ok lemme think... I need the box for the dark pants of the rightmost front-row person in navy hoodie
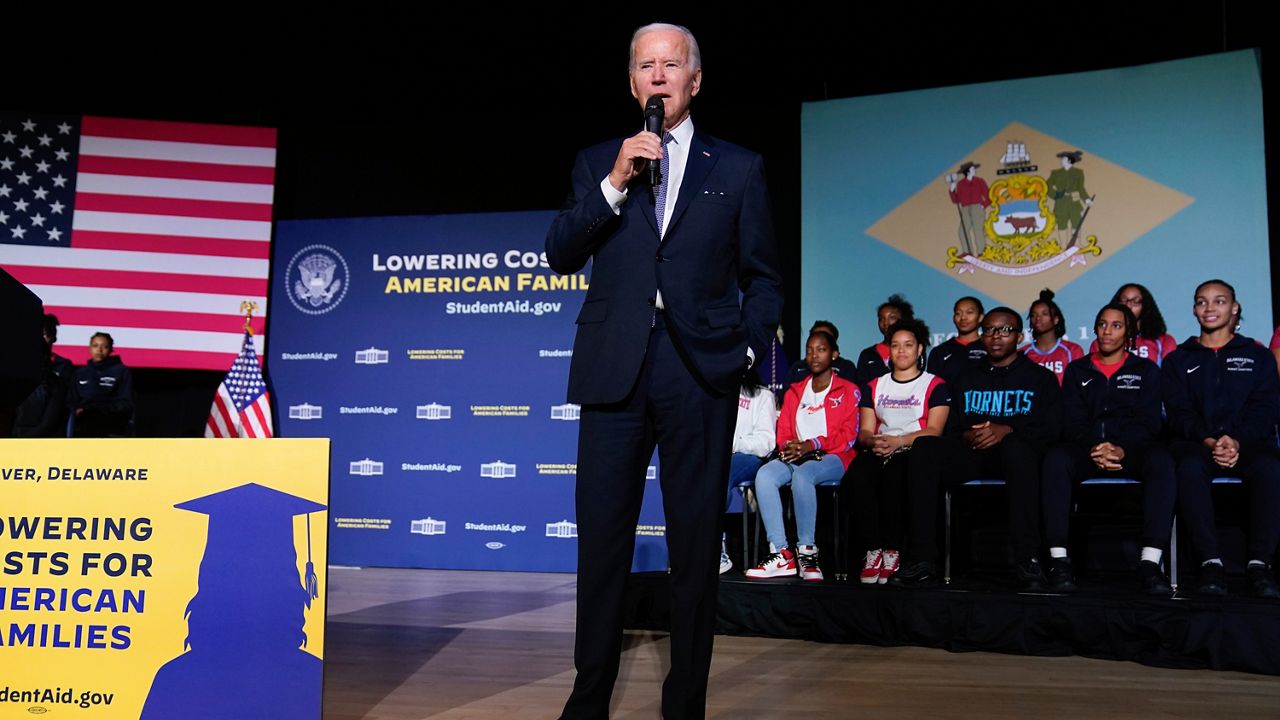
[1172,442,1280,562]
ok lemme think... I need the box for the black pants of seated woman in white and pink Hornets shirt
[841,450,914,551]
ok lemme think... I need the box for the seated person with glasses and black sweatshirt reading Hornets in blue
[890,307,1062,591]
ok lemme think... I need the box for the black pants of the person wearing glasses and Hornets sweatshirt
[906,433,1041,562]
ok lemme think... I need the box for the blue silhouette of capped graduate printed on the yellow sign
[141,483,325,720]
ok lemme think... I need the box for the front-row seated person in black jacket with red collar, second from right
[1041,302,1175,596]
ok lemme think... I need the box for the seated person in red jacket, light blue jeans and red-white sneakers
[746,331,859,580]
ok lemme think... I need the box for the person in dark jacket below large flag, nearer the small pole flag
[72,333,133,437]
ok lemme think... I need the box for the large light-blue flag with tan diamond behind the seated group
[801,49,1274,355]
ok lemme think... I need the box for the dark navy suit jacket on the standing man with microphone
[547,132,782,404]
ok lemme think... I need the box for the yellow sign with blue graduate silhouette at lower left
[0,439,329,720]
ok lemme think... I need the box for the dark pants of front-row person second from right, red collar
[1041,442,1176,547]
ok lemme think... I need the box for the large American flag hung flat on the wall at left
[0,114,275,370]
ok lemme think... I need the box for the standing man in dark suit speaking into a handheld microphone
[547,24,782,720]
